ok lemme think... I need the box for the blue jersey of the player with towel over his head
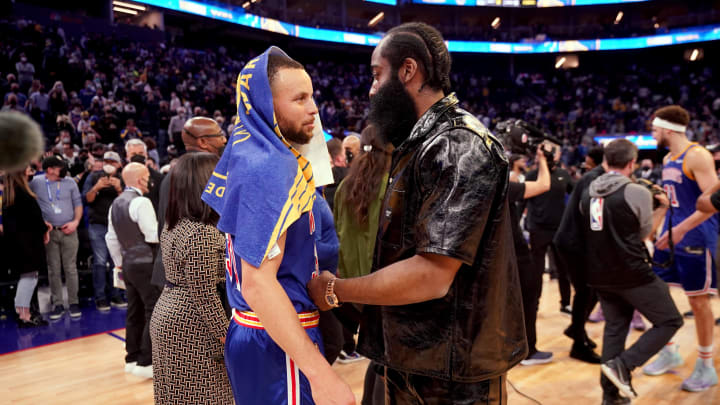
[225,211,318,313]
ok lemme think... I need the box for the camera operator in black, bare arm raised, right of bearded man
[508,146,553,365]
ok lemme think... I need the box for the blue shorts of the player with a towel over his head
[225,310,322,405]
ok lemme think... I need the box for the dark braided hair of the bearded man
[381,22,452,93]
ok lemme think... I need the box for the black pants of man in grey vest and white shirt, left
[123,263,162,366]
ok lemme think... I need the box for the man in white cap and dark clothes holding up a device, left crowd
[83,152,127,311]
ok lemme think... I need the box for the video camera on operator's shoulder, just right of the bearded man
[495,118,562,168]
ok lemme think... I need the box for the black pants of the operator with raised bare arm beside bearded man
[517,249,542,356]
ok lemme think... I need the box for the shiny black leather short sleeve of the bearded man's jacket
[415,128,507,265]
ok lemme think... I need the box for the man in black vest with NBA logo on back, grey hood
[580,139,683,404]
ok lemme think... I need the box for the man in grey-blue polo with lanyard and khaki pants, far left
[30,156,83,320]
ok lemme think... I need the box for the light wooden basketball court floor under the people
[0,281,720,405]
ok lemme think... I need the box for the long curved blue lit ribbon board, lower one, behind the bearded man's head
[135,0,720,54]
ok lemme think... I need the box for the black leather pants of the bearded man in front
[385,367,507,405]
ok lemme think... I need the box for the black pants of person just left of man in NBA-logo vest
[555,248,597,344]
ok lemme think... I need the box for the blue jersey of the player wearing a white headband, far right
[662,143,718,255]
